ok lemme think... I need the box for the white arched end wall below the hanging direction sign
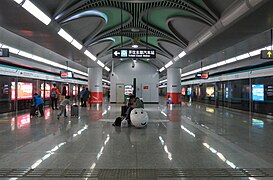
[110,60,159,102]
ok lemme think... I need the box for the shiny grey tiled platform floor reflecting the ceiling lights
[0,102,273,180]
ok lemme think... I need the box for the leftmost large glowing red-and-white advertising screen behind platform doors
[11,82,33,100]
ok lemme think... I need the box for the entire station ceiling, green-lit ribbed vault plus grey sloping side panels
[0,0,273,75]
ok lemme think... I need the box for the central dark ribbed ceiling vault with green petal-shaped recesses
[55,0,219,61]
